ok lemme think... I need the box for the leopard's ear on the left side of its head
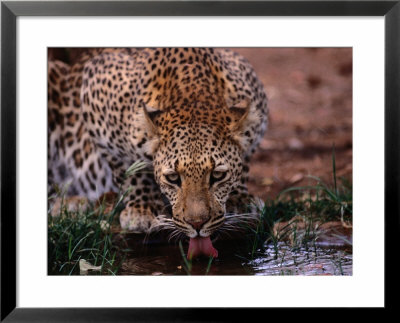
[142,103,163,156]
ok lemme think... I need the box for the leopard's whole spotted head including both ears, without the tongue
[144,100,249,238]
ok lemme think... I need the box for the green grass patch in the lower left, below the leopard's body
[48,197,121,275]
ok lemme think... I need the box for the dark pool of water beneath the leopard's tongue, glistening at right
[119,234,353,276]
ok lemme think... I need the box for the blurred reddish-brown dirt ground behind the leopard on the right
[235,48,353,199]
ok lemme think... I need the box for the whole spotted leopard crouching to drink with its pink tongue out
[48,48,268,257]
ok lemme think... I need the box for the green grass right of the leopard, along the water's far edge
[247,147,353,259]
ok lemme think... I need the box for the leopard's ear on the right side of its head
[229,98,251,149]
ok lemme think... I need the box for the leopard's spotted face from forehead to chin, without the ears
[149,106,243,238]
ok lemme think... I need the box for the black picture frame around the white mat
[1,0,400,322]
